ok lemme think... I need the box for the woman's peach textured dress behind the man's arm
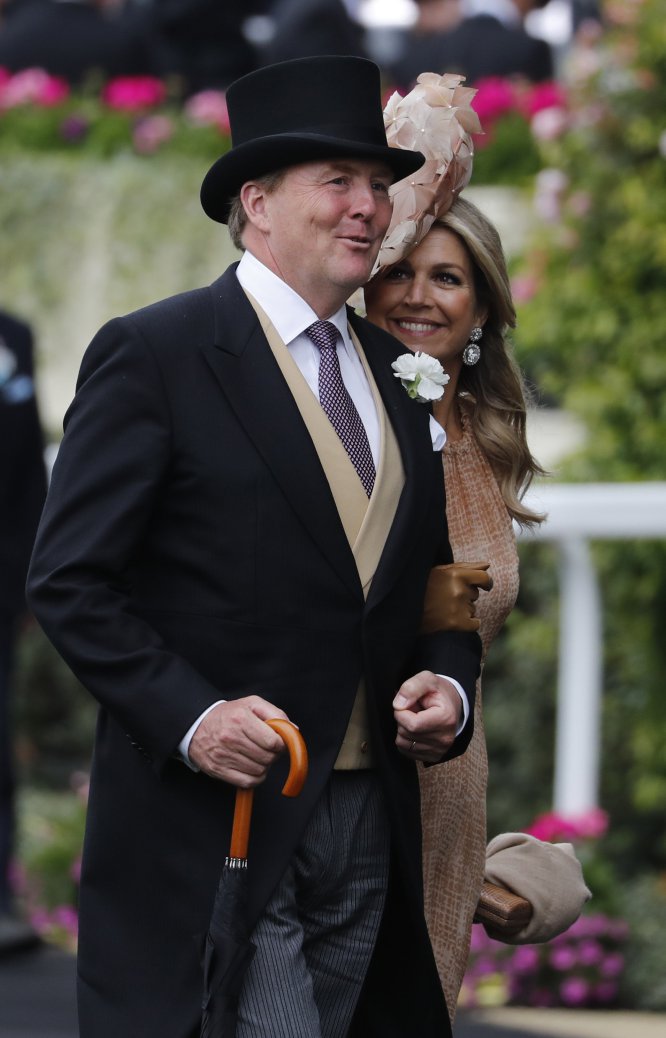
[419,422,518,1019]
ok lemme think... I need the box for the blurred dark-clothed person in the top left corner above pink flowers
[0,0,151,86]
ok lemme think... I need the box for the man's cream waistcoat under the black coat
[240,293,405,769]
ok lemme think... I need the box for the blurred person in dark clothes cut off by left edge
[0,310,47,952]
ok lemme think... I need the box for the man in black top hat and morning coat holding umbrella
[29,57,479,1038]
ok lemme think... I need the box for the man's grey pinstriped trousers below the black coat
[237,771,389,1038]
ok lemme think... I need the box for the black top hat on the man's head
[201,55,424,223]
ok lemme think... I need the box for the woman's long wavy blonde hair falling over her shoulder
[435,197,546,526]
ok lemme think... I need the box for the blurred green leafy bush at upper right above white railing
[518,0,666,481]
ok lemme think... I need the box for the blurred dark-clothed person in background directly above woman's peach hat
[390,0,554,87]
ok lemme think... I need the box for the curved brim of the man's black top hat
[201,133,425,223]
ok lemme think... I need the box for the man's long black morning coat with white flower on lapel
[28,267,480,1038]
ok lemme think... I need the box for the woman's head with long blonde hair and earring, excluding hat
[365,197,540,512]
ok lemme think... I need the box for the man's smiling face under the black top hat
[255,159,393,317]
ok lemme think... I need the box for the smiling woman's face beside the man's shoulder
[365,224,485,375]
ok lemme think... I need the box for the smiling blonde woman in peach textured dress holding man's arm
[365,133,542,1016]
